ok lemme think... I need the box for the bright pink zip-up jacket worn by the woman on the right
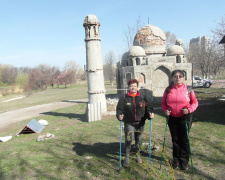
[161,84,198,117]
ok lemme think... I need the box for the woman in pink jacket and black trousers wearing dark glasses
[161,70,198,170]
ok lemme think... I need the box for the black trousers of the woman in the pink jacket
[168,114,192,164]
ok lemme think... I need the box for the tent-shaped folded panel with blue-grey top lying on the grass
[16,119,45,136]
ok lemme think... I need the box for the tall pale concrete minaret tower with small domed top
[83,14,107,114]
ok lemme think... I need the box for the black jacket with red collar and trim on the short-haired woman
[116,91,153,122]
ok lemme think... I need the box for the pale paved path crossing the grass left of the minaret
[0,99,88,133]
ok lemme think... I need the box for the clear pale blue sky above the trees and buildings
[0,0,225,68]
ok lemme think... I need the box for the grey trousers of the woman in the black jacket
[124,122,144,157]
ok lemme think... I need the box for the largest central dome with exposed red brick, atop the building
[133,24,166,54]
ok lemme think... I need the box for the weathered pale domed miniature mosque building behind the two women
[117,25,192,100]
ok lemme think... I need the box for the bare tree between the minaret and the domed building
[103,51,116,85]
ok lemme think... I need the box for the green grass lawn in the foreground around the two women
[0,87,225,180]
